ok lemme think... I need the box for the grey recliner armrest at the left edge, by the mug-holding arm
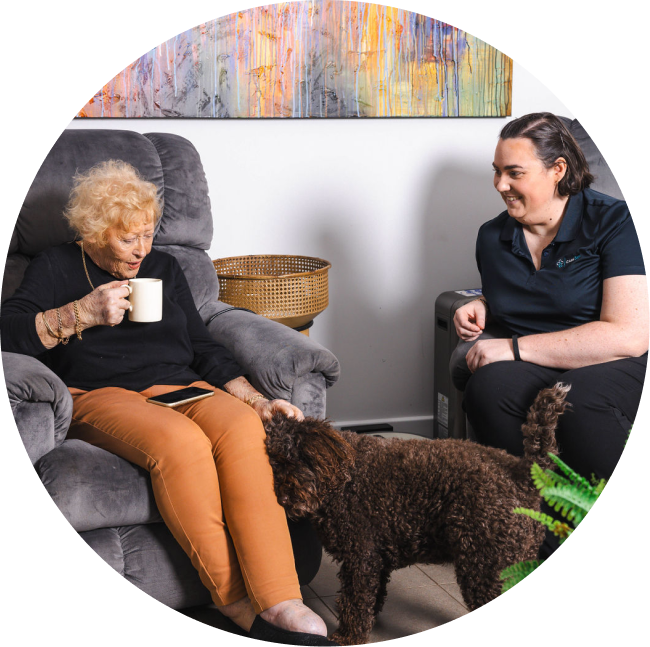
[2,351,72,464]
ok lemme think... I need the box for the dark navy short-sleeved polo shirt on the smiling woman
[476,189,646,335]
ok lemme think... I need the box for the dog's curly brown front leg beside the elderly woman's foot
[331,551,382,645]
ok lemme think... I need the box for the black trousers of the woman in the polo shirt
[464,355,648,557]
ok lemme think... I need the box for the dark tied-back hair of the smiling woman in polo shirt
[499,112,594,195]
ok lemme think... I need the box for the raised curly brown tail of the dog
[521,382,571,474]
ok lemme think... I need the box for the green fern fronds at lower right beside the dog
[500,425,634,594]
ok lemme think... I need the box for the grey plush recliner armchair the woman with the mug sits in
[2,129,339,609]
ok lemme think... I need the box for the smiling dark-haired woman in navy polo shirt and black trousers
[454,113,650,555]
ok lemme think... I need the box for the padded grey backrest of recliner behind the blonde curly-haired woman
[1,129,218,306]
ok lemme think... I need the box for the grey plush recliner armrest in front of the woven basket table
[208,303,340,408]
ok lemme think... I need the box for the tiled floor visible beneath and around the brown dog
[182,554,468,643]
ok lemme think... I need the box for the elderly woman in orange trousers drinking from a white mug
[0,161,334,645]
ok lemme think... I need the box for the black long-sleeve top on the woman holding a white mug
[0,243,244,391]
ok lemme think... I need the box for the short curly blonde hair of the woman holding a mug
[63,160,162,247]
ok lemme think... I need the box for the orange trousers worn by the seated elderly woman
[68,382,301,613]
